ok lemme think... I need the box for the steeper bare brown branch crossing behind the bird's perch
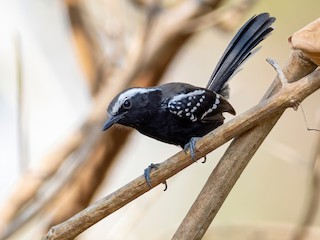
[173,51,317,239]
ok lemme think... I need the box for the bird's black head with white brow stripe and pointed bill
[103,87,161,131]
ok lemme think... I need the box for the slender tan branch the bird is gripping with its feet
[43,58,320,240]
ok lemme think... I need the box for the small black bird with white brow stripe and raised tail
[103,13,276,187]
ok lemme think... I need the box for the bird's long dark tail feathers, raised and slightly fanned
[207,13,276,97]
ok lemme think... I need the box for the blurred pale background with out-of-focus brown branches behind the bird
[0,0,320,239]
